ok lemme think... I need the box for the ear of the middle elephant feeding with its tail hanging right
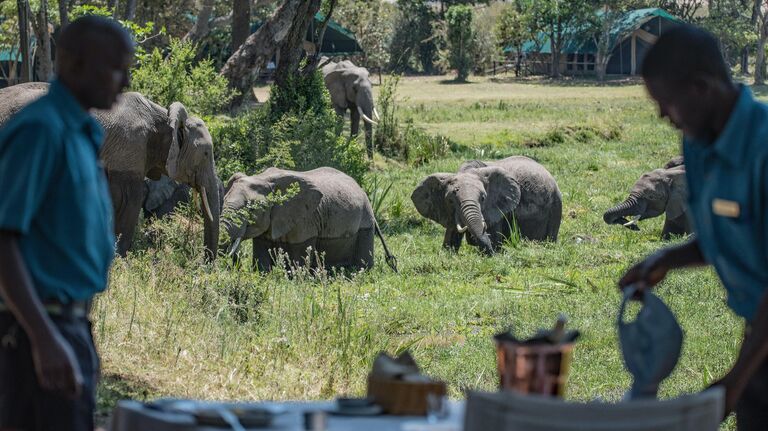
[271,178,323,240]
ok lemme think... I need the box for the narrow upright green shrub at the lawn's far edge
[445,5,474,82]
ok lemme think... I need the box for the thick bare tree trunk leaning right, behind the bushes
[220,0,320,107]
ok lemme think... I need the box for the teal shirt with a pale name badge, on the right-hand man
[683,86,768,321]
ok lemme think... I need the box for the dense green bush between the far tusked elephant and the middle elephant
[208,72,368,182]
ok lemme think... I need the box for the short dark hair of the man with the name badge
[640,24,731,83]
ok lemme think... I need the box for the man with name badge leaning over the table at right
[619,26,768,430]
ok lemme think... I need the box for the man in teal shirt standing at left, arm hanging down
[0,17,133,431]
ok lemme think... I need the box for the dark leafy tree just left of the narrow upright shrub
[389,0,439,74]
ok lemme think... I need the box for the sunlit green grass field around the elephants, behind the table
[94,78,741,429]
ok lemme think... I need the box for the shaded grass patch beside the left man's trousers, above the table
[96,373,157,427]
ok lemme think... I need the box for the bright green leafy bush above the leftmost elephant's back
[131,39,235,115]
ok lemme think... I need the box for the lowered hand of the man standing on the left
[31,331,83,398]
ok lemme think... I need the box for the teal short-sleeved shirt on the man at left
[0,81,115,303]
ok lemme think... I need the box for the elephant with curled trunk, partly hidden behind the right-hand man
[603,165,691,239]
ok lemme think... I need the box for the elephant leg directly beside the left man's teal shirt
[107,172,144,257]
